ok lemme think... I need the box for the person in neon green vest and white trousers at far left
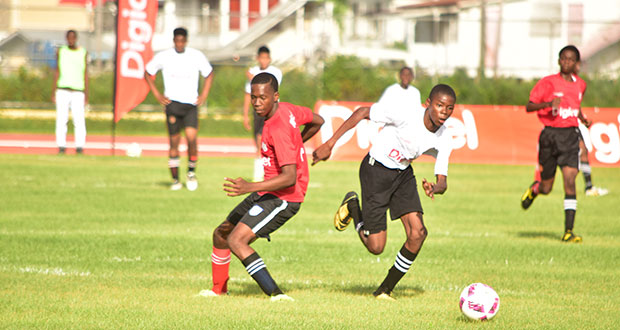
[52,30,88,154]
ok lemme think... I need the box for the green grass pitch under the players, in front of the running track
[0,155,620,329]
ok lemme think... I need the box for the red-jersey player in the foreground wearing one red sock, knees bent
[199,72,323,301]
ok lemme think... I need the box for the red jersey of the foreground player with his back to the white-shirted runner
[259,102,313,203]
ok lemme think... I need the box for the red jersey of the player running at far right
[530,73,586,127]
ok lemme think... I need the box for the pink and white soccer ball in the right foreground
[459,283,499,321]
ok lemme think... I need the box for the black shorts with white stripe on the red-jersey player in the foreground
[226,193,301,238]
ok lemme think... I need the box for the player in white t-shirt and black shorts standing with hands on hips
[144,28,213,191]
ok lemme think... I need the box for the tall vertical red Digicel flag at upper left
[114,0,157,122]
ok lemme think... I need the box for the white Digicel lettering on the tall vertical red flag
[120,0,153,79]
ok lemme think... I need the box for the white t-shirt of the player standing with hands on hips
[146,47,213,104]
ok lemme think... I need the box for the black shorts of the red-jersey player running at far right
[538,127,581,180]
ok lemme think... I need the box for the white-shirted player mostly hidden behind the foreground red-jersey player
[243,46,282,182]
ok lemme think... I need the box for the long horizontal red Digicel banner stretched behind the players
[313,101,620,167]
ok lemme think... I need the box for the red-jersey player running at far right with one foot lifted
[521,45,590,243]
